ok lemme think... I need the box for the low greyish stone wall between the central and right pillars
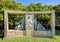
[34,31,52,37]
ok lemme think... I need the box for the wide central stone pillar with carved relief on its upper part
[25,14,34,37]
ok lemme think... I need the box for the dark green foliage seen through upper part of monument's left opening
[8,15,24,25]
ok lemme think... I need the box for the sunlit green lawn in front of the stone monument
[0,31,60,42]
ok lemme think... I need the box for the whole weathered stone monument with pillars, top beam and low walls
[4,10,55,38]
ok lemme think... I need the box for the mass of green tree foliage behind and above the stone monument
[0,0,60,27]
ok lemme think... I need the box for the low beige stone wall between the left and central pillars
[7,30,25,38]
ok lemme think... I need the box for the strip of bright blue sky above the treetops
[15,0,60,5]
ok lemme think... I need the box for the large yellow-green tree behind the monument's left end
[0,0,26,28]
